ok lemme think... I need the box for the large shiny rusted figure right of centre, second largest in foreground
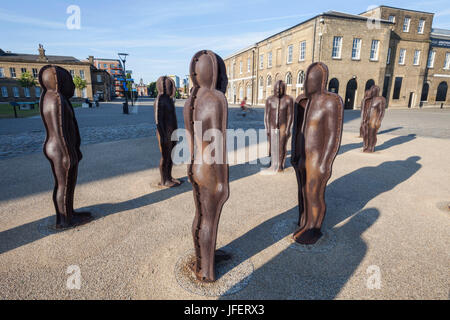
[291,62,344,244]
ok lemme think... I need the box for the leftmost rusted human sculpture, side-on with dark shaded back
[39,65,92,228]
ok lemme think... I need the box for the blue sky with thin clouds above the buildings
[0,0,450,83]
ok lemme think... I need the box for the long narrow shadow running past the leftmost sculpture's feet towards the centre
[0,163,261,254]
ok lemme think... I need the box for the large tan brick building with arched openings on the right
[225,6,450,109]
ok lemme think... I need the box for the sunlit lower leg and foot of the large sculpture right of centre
[293,165,327,244]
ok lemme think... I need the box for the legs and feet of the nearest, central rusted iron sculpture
[192,185,228,282]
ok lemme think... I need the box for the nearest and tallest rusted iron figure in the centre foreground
[183,50,229,282]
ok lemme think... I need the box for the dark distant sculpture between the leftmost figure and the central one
[154,77,181,188]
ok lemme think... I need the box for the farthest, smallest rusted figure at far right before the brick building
[363,86,386,153]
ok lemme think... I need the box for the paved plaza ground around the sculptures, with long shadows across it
[0,99,450,299]
